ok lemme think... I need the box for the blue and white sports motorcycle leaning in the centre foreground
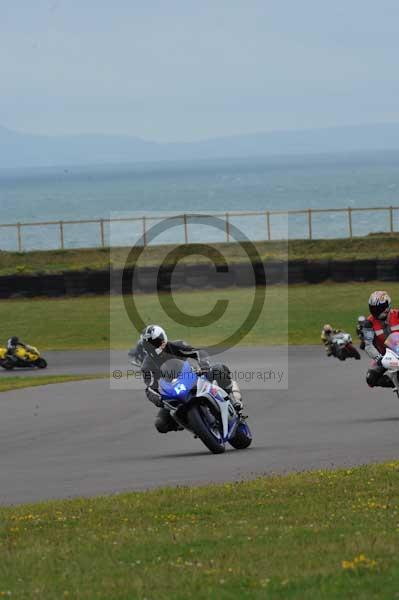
[159,360,252,454]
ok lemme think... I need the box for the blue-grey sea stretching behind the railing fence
[0,151,399,250]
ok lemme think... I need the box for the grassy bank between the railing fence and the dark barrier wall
[0,233,399,275]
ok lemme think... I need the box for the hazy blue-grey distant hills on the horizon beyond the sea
[0,123,399,168]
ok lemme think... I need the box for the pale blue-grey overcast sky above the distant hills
[0,0,399,141]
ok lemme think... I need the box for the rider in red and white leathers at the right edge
[363,291,399,387]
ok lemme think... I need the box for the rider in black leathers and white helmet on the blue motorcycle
[141,325,242,433]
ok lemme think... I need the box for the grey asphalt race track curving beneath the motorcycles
[0,347,399,504]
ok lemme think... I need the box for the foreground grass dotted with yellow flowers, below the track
[0,462,399,600]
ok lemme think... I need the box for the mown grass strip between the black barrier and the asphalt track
[0,282,399,350]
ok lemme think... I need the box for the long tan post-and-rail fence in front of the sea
[0,206,399,252]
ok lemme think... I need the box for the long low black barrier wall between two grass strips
[0,258,399,298]
